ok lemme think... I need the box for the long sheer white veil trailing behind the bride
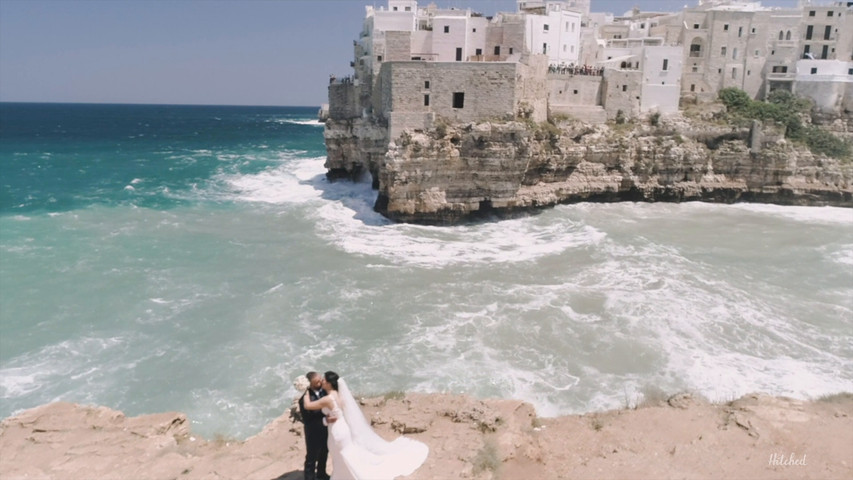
[338,378,429,476]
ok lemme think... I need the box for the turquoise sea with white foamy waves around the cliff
[0,103,853,438]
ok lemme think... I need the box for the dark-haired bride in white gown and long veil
[304,372,429,480]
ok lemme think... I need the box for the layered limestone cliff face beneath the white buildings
[326,119,853,224]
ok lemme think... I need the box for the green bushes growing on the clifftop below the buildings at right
[720,88,853,161]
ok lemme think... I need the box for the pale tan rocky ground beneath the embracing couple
[0,394,853,480]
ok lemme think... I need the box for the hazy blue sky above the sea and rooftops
[0,0,796,106]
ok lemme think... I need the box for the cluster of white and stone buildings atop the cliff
[329,0,853,138]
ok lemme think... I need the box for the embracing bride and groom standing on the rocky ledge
[299,372,429,480]
